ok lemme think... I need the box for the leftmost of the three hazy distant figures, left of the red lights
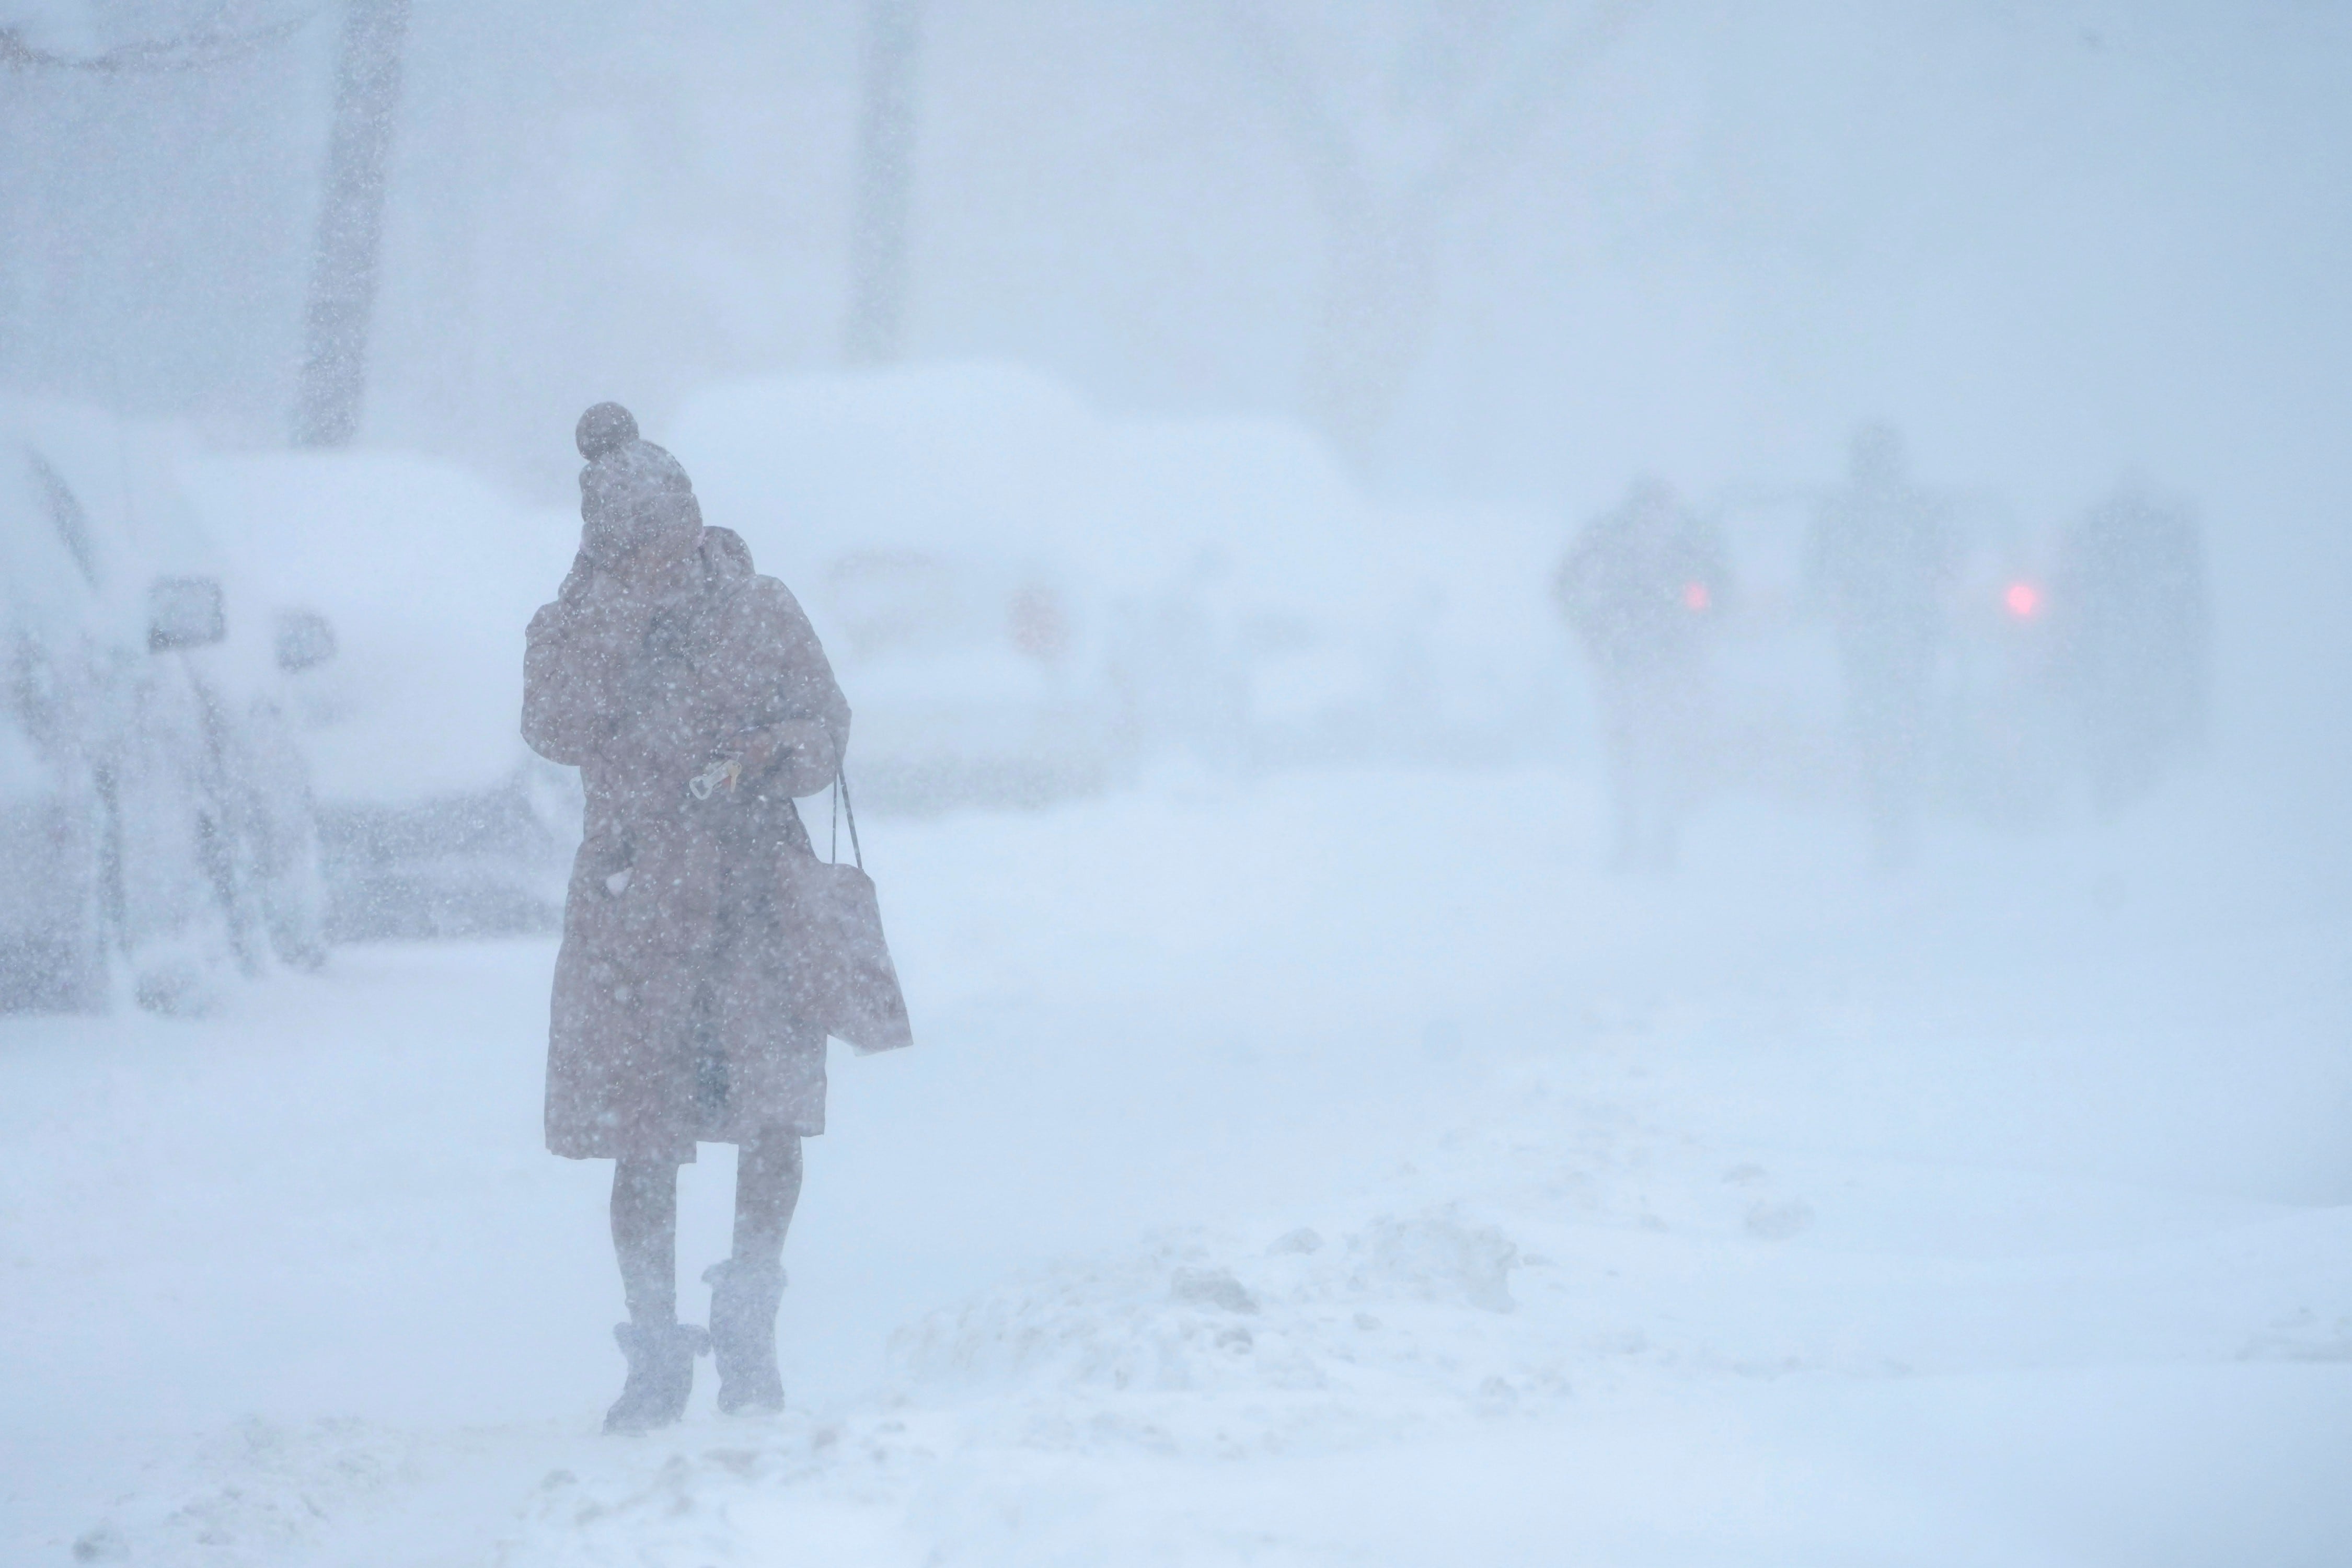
[1552,480,1726,870]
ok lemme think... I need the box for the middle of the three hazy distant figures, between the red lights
[1811,425,1959,870]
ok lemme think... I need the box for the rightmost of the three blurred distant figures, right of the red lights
[2051,482,2206,818]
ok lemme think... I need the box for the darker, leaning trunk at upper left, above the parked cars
[294,0,409,447]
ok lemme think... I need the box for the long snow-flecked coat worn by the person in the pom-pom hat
[522,529,849,1161]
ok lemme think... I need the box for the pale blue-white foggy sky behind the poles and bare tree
[0,0,2352,841]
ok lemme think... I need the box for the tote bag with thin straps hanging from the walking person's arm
[783,774,915,1055]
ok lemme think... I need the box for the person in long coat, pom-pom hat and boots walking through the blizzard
[522,405,849,1432]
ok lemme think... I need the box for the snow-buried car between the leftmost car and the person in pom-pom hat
[183,452,581,940]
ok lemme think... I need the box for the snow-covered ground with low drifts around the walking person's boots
[0,771,2352,1568]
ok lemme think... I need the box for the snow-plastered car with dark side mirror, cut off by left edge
[0,400,322,1011]
